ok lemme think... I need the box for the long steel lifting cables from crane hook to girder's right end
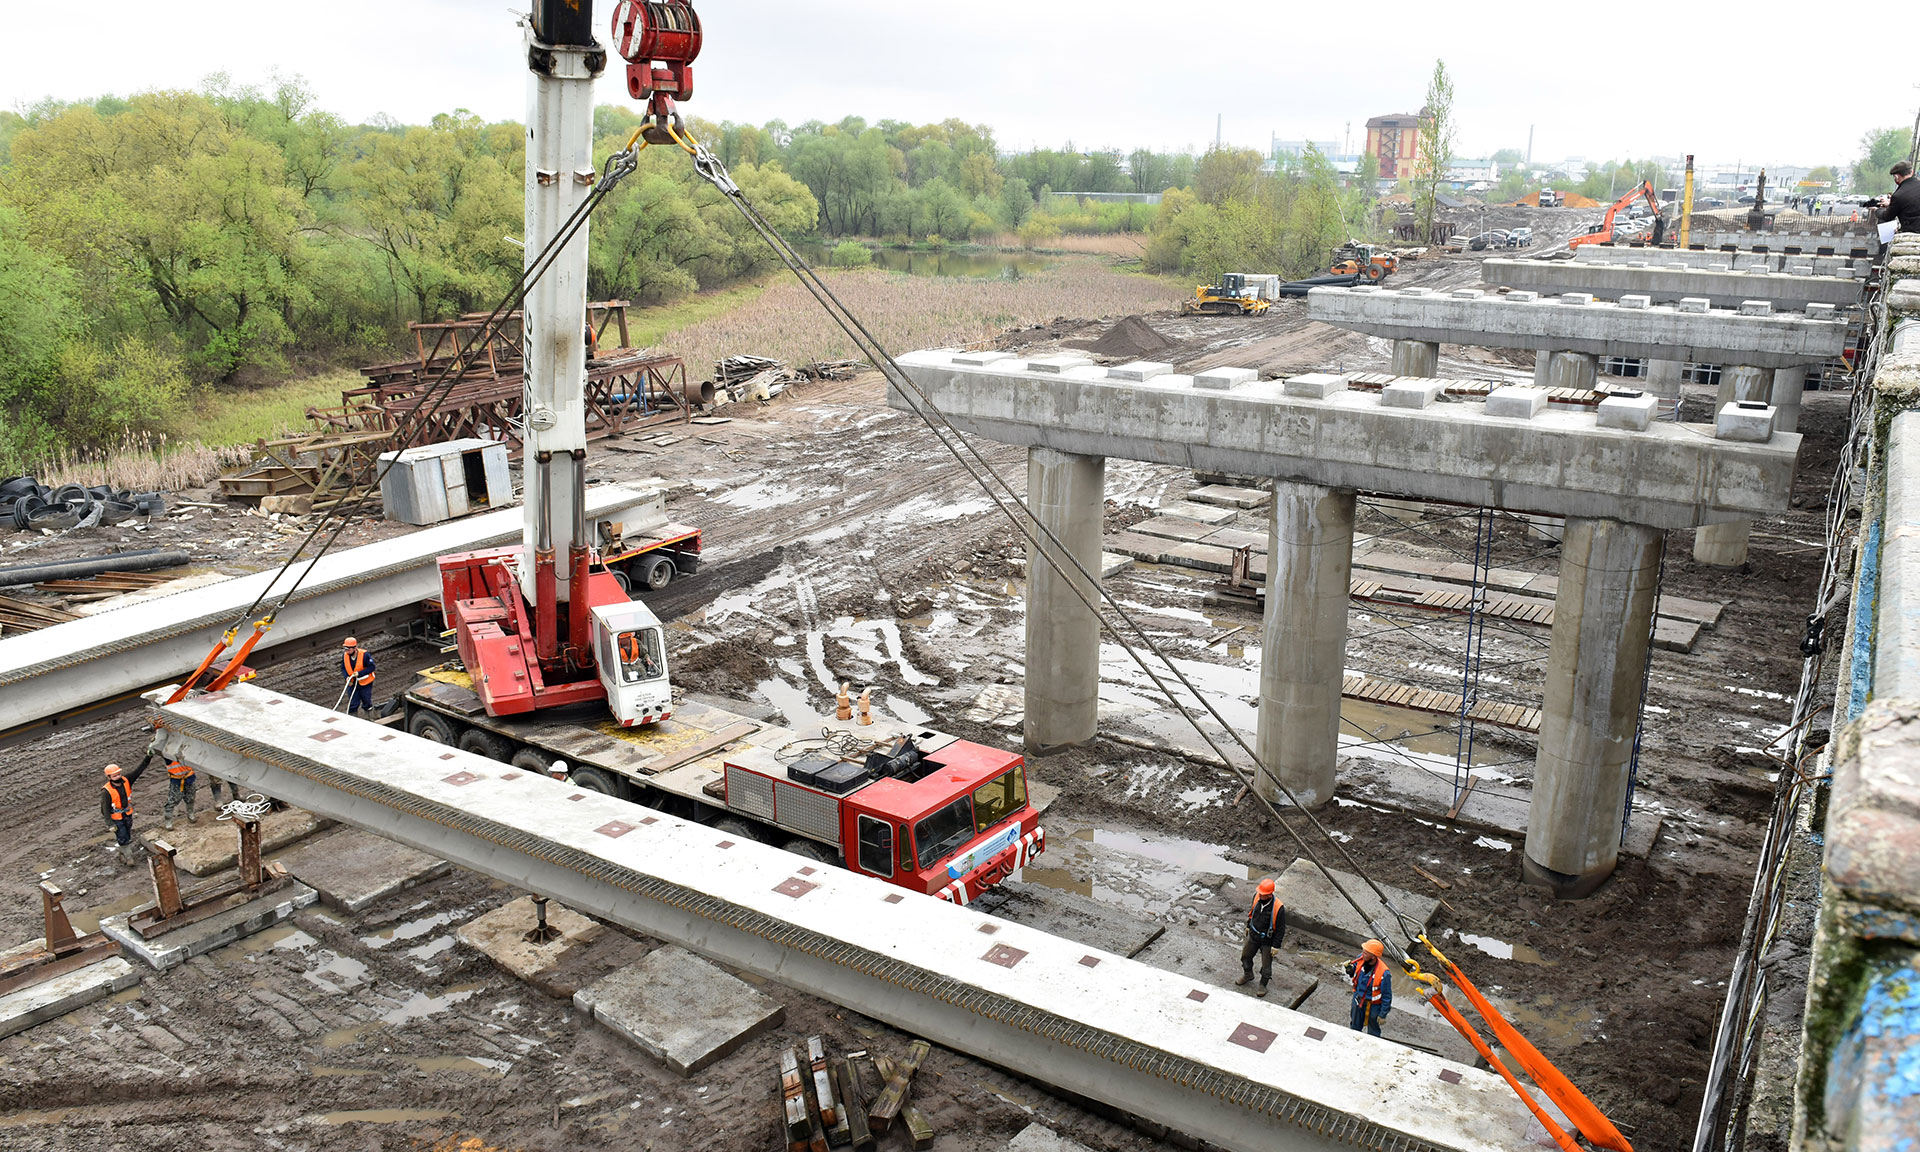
[674,127,1421,962]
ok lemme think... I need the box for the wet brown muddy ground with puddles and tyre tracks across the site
[0,213,1845,1152]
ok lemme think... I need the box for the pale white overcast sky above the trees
[0,0,1920,167]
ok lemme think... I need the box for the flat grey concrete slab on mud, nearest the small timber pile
[574,947,787,1075]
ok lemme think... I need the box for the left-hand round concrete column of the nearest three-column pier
[1025,447,1106,751]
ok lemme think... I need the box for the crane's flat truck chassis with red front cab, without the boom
[394,664,1046,904]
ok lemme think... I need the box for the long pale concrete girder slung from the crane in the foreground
[157,684,1559,1152]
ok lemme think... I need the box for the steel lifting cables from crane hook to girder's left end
[168,131,647,693]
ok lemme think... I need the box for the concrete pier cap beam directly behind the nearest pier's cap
[1308,286,1847,369]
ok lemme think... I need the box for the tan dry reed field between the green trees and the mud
[662,261,1181,378]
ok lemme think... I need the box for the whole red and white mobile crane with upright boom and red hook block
[390,0,1044,902]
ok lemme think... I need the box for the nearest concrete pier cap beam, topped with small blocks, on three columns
[889,353,1799,528]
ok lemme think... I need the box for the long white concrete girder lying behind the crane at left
[0,486,666,737]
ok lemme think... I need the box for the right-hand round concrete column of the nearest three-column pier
[1523,518,1663,899]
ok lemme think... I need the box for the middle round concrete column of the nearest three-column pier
[1254,480,1354,808]
